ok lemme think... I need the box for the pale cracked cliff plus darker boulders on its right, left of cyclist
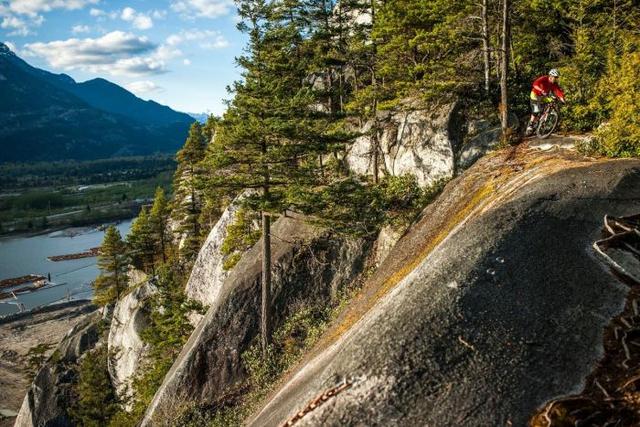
[345,100,501,186]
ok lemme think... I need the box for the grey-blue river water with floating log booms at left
[0,220,131,317]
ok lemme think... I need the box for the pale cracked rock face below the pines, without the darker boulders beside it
[345,104,463,186]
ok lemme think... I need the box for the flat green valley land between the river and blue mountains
[0,156,175,234]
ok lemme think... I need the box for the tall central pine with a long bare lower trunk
[207,0,335,349]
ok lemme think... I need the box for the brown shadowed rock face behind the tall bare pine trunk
[143,217,371,426]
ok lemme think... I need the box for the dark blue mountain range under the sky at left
[0,43,195,163]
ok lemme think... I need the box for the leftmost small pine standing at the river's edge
[93,226,129,306]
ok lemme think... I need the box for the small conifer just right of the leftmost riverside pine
[127,206,158,273]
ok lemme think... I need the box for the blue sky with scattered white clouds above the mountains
[0,0,245,115]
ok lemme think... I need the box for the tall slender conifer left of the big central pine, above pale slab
[172,122,206,263]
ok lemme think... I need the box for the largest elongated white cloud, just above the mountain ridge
[25,31,170,77]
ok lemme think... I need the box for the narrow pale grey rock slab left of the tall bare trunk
[185,194,248,306]
